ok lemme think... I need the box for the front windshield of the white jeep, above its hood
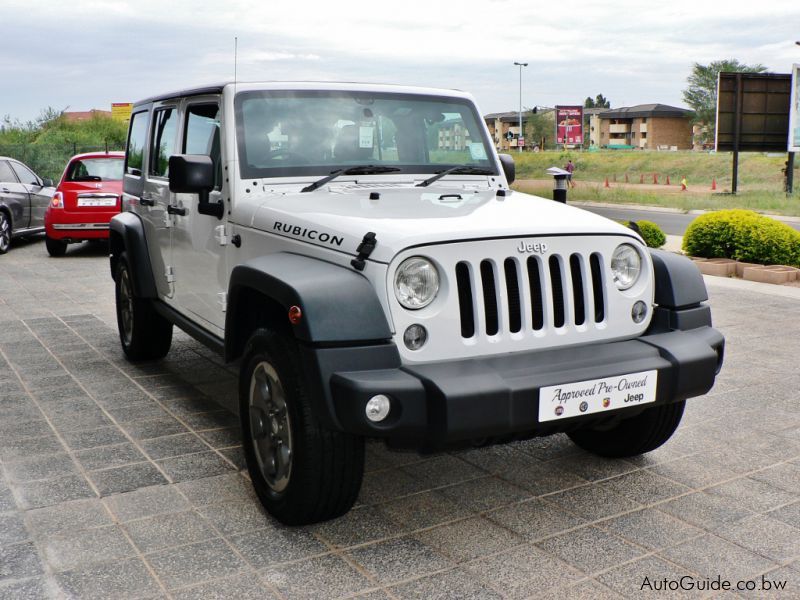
[235,91,497,179]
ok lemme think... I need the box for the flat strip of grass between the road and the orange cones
[512,181,800,216]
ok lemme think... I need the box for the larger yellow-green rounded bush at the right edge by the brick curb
[683,209,800,267]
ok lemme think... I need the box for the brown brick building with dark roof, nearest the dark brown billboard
[589,104,694,150]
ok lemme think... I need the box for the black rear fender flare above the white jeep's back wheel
[109,212,158,298]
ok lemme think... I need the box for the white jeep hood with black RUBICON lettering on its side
[245,186,635,263]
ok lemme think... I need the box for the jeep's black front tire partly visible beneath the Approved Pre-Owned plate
[567,400,686,458]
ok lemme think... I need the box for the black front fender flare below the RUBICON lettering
[225,252,392,360]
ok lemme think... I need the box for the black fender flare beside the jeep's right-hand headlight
[649,249,708,309]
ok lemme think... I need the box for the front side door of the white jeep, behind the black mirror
[172,96,227,336]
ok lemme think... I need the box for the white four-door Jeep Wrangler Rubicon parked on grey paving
[111,83,724,524]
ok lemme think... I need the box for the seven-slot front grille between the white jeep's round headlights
[455,252,607,339]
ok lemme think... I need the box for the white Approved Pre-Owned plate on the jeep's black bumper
[539,370,658,423]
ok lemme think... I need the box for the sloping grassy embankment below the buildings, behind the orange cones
[513,150,800,192]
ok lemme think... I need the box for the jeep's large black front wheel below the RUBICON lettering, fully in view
[239,329,364,525]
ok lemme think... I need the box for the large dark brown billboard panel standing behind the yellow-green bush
[716,73,792,152]
